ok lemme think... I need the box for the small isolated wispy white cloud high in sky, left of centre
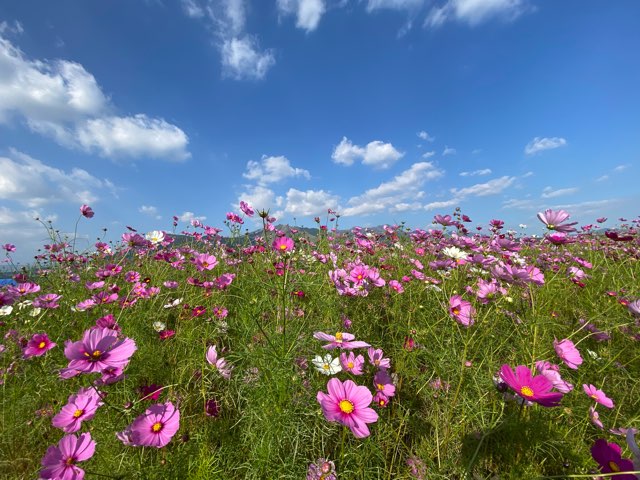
[221,36,276,80]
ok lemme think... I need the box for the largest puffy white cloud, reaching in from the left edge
[0,34,189,160]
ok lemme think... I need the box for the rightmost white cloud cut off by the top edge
[425,0,530,27]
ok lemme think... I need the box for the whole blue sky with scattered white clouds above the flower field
[0,0,640,261]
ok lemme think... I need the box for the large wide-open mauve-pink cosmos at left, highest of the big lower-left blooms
[64,328,136,373]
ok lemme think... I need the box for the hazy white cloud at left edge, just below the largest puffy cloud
[0,150,113,208]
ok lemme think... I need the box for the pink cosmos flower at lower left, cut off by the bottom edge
[40,433,96,480]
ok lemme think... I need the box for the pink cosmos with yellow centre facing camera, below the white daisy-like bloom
[316,378,378,438]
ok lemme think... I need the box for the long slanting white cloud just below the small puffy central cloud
[343,162,444,216]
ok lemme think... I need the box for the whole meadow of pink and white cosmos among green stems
[0,202,640,480]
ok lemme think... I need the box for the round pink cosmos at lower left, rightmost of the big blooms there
[129,402,180,448]
